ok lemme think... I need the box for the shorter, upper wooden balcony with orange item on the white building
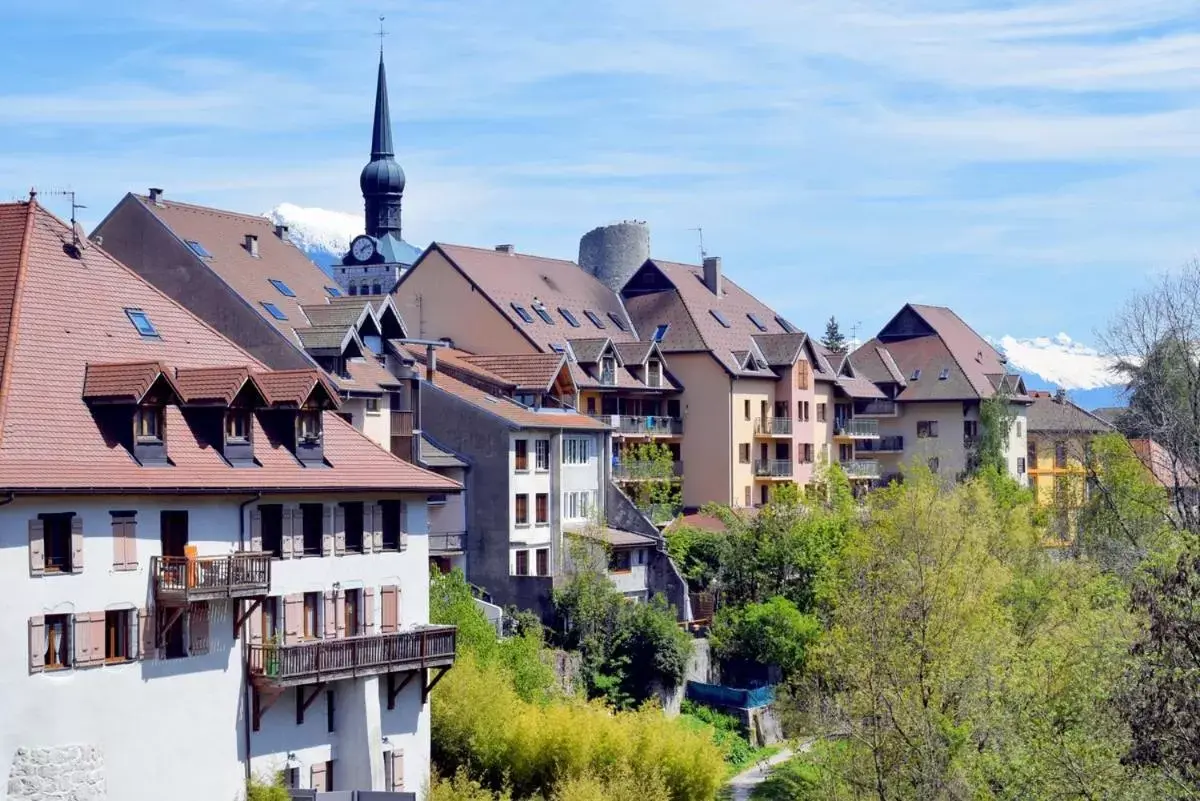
[150,552,271,606]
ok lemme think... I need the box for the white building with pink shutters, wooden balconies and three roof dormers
[0,200,460,801]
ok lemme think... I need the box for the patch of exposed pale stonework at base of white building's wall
[7,746,108,801]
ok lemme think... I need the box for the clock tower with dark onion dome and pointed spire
[332,48,421,295]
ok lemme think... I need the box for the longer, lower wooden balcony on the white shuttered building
[250,626,457,687]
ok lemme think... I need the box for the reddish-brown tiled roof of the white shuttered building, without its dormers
[0,204,458,493]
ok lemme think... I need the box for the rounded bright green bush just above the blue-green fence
[709,596,821,677]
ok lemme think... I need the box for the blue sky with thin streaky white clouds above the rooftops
[0,0,1200,383]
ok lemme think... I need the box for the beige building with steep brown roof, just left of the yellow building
[850,303,1032,486]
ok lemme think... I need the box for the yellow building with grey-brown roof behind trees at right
[1024,390,1114,542]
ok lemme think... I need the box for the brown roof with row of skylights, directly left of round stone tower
[417,242,637,351]
